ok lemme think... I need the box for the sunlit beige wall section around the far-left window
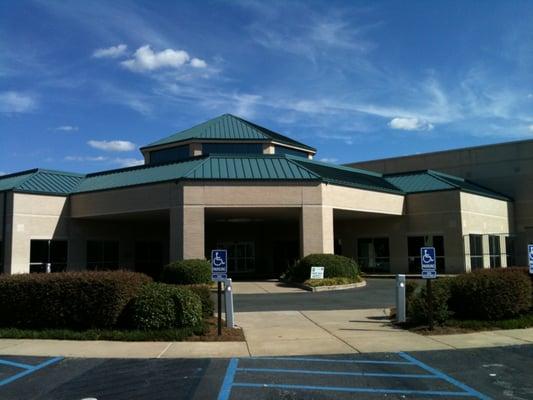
[6,193,69,274]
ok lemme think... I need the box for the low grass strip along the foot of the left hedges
[0,323,209,342]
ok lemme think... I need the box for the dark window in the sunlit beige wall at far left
[30,240,68,273]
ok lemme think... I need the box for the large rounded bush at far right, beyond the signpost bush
[450,268,532,320]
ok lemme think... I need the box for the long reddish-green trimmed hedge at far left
[0,271,151,329]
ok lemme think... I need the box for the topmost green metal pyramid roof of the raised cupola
[141,114,316,152]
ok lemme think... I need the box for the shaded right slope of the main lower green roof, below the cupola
[287,156,403,194]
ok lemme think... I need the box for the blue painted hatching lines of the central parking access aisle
[218,353,490,400]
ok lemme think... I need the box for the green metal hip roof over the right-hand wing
[384,170,510,200]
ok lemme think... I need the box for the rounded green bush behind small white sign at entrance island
[284,254,359,283]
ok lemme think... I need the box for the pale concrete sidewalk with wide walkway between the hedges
[0,309,533,358]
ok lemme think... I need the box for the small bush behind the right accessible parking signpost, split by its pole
[407,278,453,325]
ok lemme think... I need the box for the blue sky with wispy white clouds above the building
[0,0,533,173]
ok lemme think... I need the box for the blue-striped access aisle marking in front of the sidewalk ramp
[218,352,490,400]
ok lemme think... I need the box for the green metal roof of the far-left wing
[0,169,85,195]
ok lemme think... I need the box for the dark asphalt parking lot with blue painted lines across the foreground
[0,345,533,400]
